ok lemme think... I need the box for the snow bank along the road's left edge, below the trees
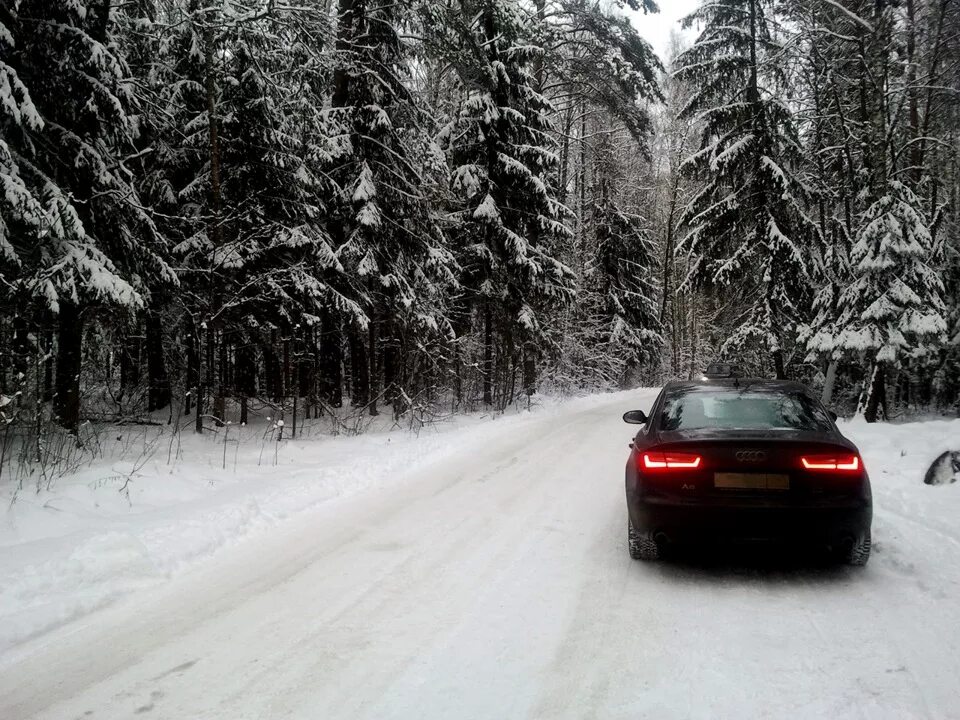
[0,395,628,654]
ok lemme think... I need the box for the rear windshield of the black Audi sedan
[660,387,831,431]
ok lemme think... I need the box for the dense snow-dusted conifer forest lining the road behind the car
[0,0,960,456]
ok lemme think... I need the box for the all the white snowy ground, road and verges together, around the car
[0,391,960,720]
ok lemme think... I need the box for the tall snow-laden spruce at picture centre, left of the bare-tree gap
[441,0,572,405]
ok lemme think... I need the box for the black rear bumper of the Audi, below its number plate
[628,496,873,545]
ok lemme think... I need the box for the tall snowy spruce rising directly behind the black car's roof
[676,0,816,377]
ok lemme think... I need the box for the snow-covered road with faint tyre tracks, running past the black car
[0,391,960,720]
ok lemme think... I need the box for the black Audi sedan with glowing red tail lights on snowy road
[623,378,873,565]
